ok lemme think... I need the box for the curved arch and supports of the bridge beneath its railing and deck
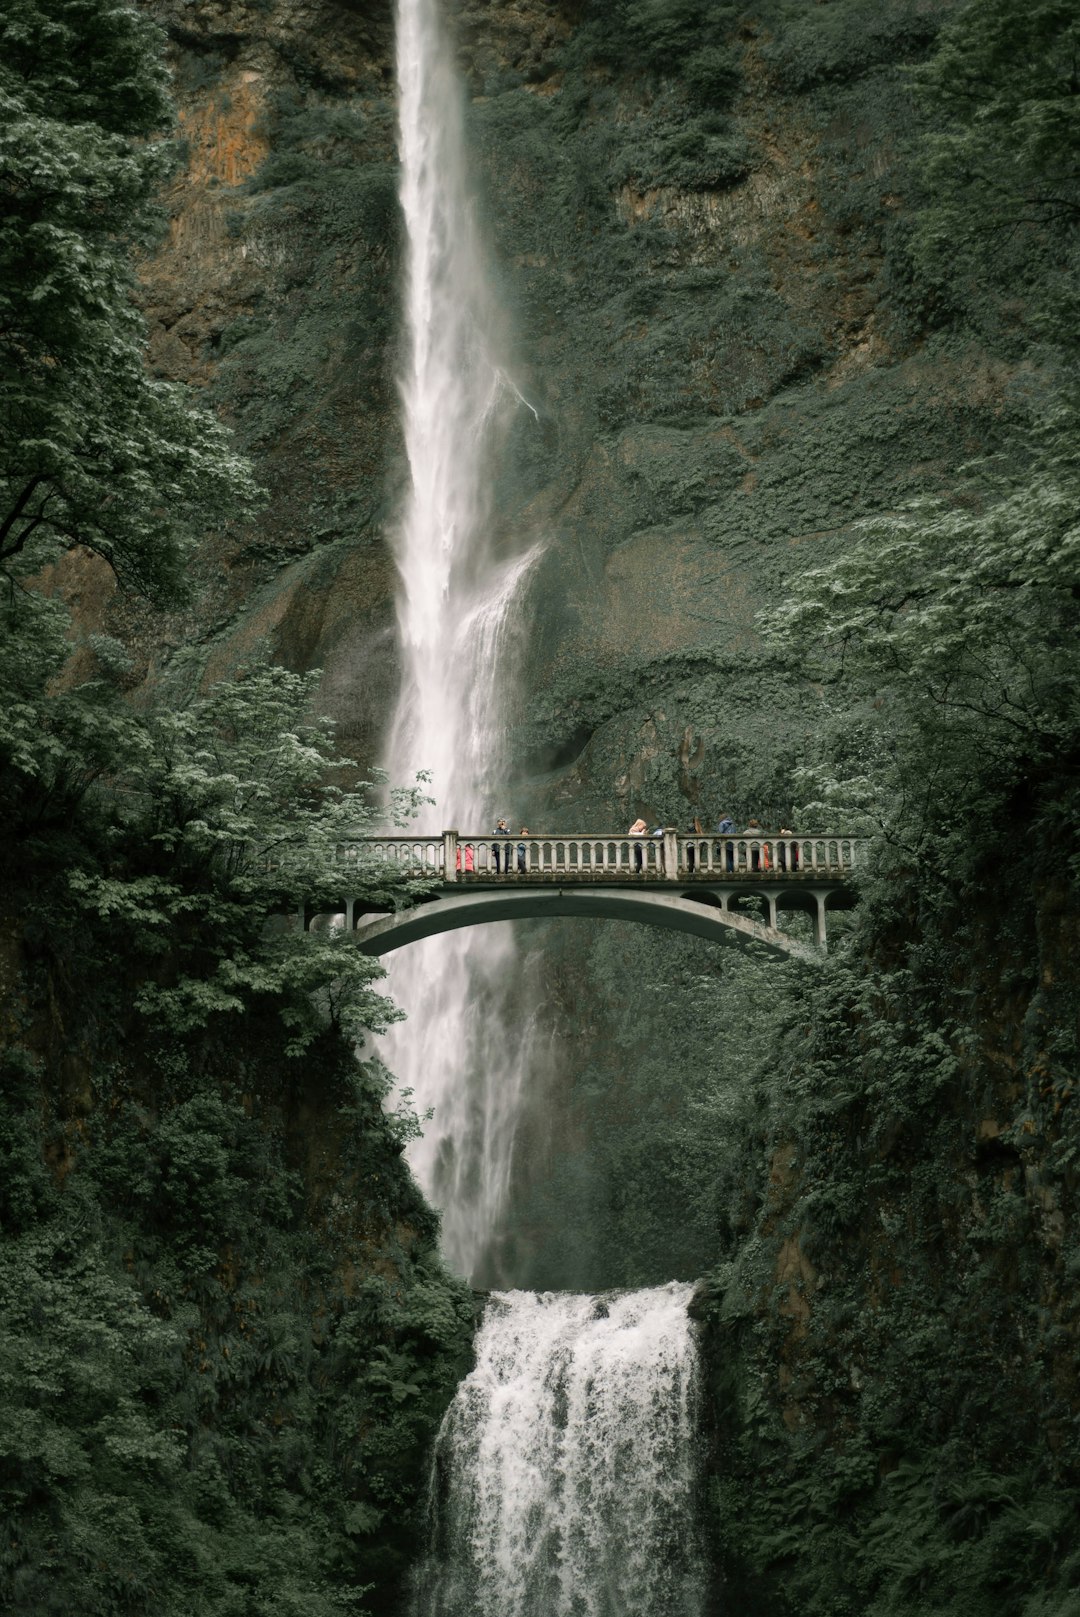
[329,884,849,960]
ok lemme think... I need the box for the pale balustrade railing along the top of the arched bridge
[338,831,860,881]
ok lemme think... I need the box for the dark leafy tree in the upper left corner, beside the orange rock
[0,0,254,602]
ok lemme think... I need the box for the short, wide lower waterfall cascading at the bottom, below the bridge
[412,1282,705,1617]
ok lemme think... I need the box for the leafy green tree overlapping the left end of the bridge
[68,665,427,1054]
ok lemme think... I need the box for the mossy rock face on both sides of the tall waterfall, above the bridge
[88,0,989,825]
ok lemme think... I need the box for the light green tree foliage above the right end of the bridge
[759,424,1080,847]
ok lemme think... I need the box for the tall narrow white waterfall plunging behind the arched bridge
[385,0,532,1276]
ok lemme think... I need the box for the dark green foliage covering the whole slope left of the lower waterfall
[0,593,472,1617]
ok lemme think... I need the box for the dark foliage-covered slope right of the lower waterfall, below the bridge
[705,899,1080,1617]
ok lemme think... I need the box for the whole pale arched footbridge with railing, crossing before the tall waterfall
[301,831,860,959]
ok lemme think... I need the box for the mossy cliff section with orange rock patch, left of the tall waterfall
[74,5,399,757]
